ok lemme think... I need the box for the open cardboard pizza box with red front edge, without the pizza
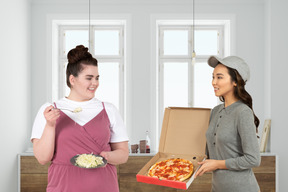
[136,107,211,189]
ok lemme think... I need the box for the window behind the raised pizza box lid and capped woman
[157,21,225,130]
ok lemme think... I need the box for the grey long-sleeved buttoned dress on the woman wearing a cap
[206,101,261,192]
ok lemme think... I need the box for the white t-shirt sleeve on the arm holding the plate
[104,102,129,143]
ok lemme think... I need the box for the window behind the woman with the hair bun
[56,22,125,116]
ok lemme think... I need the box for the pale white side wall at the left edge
[0,0,31,192]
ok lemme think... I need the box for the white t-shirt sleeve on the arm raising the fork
[30,103,51,141]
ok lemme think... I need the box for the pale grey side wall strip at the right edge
[267,0,288,192]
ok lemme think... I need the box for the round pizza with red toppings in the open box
[148,158,193,181]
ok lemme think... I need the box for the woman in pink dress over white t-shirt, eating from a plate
[31,45,129,192]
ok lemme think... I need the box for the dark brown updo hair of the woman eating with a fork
[66,45,98,88]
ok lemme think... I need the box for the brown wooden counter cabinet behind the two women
[18,154,277,192]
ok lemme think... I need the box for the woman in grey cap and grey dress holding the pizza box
[196,56,261,192]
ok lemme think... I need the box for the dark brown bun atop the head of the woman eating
[67,45,92,64]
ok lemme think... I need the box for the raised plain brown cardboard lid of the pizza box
[159,107,211,155]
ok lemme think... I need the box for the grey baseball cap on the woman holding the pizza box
[208,56,250,82]
